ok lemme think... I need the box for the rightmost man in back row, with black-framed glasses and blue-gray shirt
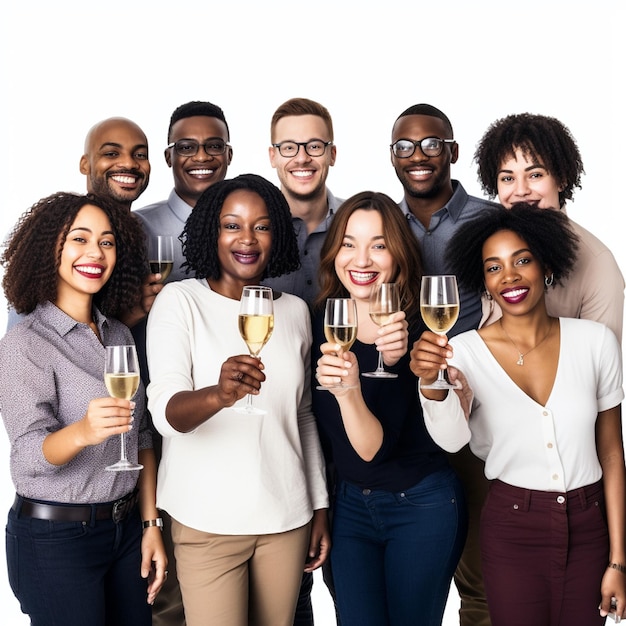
[389,104,497,626]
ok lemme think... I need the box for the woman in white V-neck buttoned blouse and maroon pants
[411,205,626,626]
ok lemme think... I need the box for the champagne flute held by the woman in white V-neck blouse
[420,275,459,389]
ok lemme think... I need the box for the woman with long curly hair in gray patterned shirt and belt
[0,193,166,626]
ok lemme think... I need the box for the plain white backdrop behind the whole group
[0,0,626,626]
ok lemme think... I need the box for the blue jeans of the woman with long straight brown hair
[331,469,467,626]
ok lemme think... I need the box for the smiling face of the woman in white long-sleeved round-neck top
[210,189,272,298]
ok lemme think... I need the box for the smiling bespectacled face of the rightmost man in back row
[391,115,458,206]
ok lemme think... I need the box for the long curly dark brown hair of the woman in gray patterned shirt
[2,192,148,317]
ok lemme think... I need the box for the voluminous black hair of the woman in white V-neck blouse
[446,203,578,293]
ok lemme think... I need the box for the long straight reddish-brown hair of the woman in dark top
[314,191,423,323]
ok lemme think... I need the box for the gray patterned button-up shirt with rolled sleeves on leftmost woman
[0,302,152,503]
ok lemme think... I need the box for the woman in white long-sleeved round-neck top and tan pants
[147,174,329,626]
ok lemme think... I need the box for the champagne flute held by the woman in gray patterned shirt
[104,346,143,472]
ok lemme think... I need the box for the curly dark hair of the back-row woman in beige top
[474,113,585,207]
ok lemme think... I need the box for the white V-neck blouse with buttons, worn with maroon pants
[422,318,624,493]
